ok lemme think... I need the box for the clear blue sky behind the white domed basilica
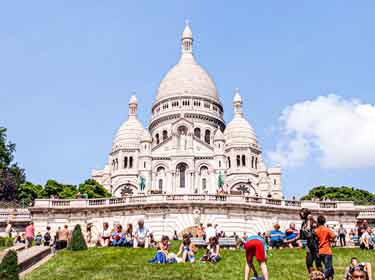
[0,0,375,196]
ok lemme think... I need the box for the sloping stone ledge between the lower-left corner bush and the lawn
[18,246,51,272]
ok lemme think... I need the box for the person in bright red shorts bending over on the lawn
[244,235,269,280]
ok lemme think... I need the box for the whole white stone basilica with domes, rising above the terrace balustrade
[92,24,282,198]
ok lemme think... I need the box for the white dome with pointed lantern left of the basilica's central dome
[112,96,144,151]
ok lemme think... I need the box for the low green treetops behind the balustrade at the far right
[302,186,375,205]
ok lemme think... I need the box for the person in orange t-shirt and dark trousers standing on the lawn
[315,216,336,280]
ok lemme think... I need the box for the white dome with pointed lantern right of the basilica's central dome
[224,89,258,146]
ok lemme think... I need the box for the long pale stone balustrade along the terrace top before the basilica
[34,194,364,210]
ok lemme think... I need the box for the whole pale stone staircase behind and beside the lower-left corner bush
[0,244,52,273]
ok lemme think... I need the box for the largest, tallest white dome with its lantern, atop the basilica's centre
[156,22,220,102]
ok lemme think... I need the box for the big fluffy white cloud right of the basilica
[268,95,375,168]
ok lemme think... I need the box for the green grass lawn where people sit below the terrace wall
[25,243,375,280]
